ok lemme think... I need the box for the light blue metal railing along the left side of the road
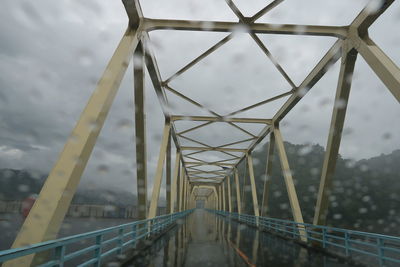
[0,210,193,267]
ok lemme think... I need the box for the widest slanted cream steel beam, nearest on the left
[4,26,140,266]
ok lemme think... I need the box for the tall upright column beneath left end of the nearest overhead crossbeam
[133,42,147,220]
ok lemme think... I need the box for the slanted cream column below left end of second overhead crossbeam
[148,121,171,219]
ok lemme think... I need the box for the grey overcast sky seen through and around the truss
[0,0,400,197]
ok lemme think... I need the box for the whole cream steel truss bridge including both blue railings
[0,0,400,266]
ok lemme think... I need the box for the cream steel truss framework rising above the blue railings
[6,0,400,266]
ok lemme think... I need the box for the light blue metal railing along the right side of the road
[208,210,400,266]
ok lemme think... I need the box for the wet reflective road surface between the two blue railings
[126,210,349,267]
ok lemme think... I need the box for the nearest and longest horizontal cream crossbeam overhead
[143,18,348,39]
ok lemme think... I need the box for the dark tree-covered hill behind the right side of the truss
[239,142,400,235]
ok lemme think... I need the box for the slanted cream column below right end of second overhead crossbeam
[274,125,307,241]
